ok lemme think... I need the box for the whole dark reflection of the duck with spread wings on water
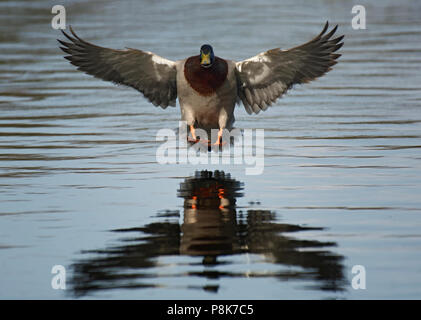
[72,171,344,295]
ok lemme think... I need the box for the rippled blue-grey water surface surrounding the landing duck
[0,0,421,299]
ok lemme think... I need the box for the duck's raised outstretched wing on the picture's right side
[236,22,344,114]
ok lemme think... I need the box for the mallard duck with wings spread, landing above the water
[58,22,344,144]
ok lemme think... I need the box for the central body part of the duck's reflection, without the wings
[179,171,242,261]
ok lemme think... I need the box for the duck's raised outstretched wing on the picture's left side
[58,27,177,108]
